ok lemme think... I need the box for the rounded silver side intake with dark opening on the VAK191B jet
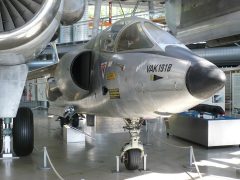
[46,50,92,101]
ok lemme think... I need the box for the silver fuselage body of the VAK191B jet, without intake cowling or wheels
[51,18,225,118]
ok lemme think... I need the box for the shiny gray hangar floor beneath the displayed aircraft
[0,111,240,180]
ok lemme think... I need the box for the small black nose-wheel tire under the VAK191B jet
[124,149,141,170]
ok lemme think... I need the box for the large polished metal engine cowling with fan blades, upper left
[0,0,64,65]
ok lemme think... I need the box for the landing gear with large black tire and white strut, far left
[0,107,34,157]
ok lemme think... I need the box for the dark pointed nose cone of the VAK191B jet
[186,62,226,99]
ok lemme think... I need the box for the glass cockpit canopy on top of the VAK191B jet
[95,17,182,52]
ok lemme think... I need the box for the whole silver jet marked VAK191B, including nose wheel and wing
[32,17,225,170]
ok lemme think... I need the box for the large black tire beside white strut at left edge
[13,107,34,156]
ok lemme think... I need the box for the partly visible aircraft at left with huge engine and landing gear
[0,0,85,157]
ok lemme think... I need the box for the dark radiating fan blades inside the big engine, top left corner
[0,0,45,33]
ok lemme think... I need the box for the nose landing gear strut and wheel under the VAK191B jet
[120,119,144,170]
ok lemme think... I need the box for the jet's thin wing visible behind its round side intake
[27,63,58,80]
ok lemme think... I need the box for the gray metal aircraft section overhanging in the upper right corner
[165,0,240,47]
